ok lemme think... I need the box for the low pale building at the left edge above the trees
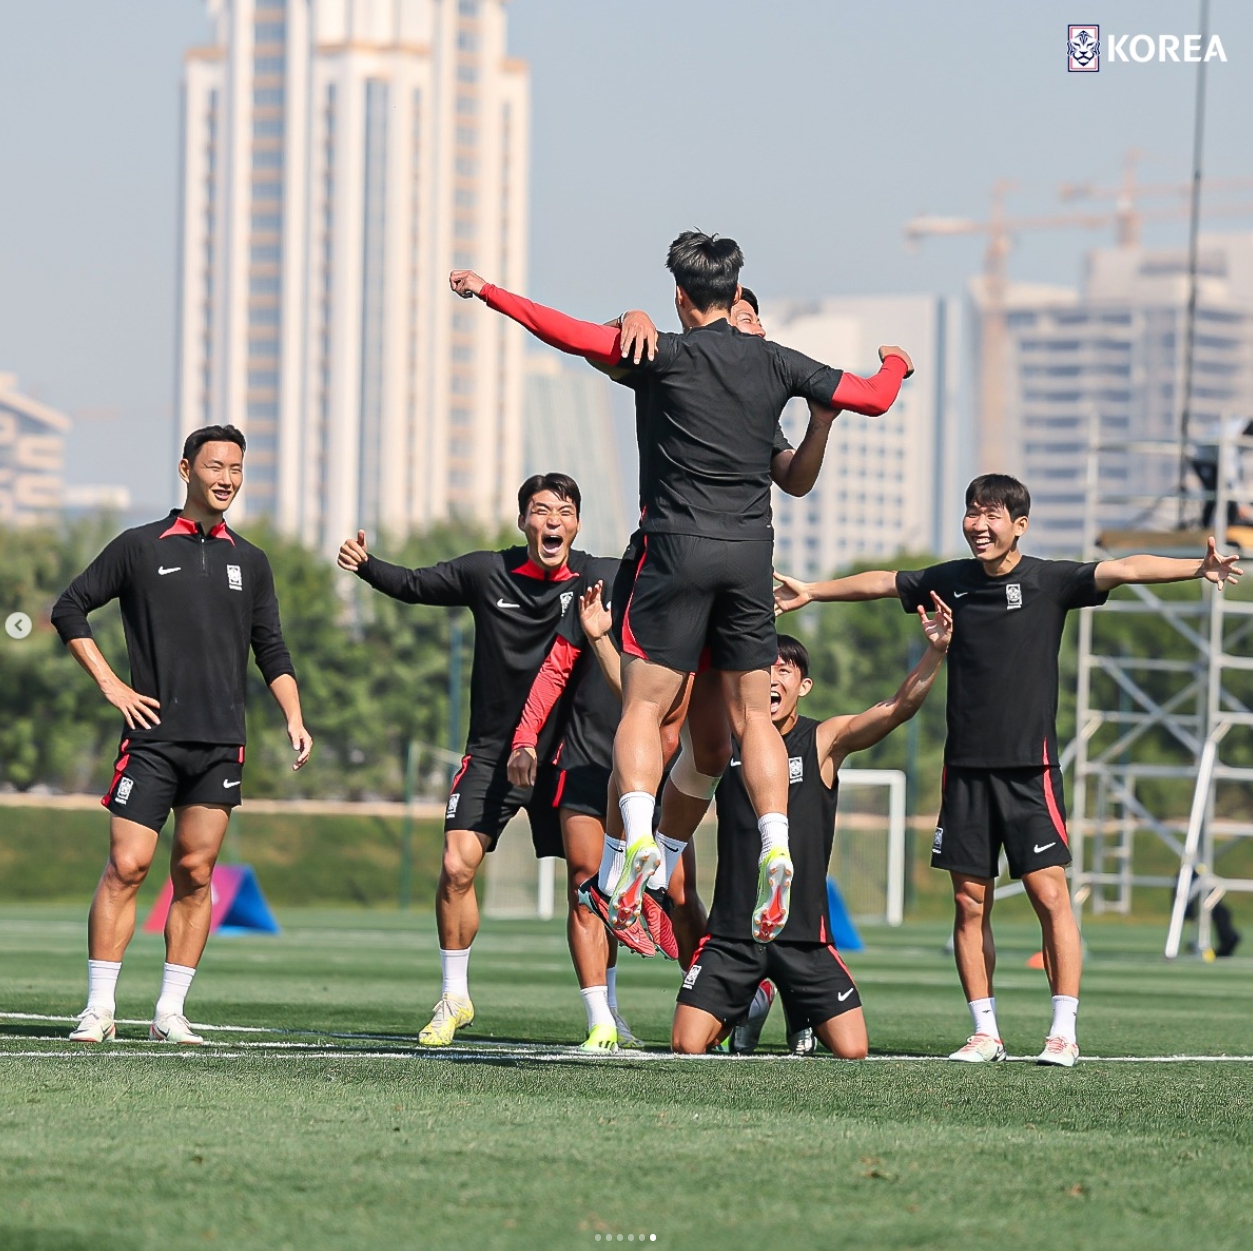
[0,374,73,525]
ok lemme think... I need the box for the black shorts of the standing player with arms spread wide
[931,765,1070,879]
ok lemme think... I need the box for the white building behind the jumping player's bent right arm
[762,296,970,578]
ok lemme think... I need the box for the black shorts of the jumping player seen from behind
[613,534,778,673]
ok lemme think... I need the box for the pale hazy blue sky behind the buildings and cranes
[0,0,1253,506]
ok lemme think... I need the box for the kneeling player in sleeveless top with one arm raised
[672,611,952,1059]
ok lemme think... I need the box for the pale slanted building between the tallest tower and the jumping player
[523,352,633,555]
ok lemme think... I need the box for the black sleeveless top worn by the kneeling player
[709,717,840,943]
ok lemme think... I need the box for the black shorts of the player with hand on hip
[100,738,243,831]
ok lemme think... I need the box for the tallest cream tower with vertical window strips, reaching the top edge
[178,0,529,550]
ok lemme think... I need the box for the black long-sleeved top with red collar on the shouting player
[357,547,588,760]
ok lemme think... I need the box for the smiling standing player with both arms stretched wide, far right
[776,474,1242,1068]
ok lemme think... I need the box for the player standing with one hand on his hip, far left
[53,426,313,1044]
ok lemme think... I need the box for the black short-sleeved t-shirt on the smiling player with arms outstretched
[896,557,1109,768]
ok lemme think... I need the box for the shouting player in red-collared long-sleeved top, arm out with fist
[340,474,586,1047]
